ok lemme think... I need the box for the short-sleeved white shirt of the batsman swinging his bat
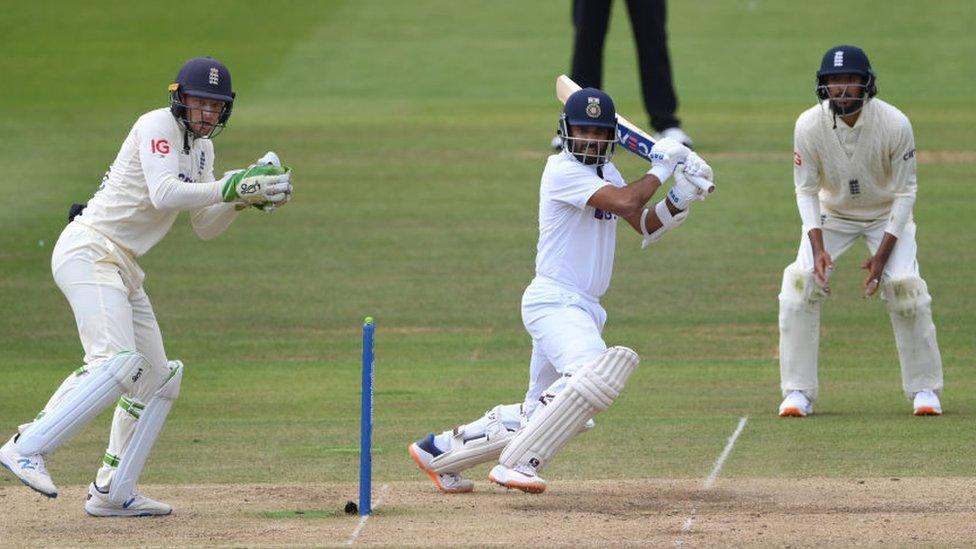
[535,152,625,299]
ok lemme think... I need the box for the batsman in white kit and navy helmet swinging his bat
[409,88,712,493]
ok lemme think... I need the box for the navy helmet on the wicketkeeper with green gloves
[169,57,236,137]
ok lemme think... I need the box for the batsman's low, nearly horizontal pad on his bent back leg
[430,404,521,474]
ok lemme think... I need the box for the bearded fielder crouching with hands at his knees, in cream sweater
[779,46,942,417]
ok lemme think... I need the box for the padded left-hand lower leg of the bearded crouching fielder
[779,265,827,400]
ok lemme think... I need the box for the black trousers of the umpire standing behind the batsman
[572,0,681,132]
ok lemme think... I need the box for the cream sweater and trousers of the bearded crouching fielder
[779,98,942,399]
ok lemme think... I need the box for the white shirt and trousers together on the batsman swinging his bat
[522,152,625,414]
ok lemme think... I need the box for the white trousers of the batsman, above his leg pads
[522,276,607,418]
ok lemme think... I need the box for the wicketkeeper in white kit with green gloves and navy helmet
[0,57,291,516]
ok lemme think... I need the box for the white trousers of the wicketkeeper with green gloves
[30,221,169,488]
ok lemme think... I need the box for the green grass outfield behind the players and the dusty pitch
[0,0,976,500]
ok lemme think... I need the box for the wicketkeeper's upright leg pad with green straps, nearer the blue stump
[108,361,183,505]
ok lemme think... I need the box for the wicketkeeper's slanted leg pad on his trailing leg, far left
[17,352,152,455]
